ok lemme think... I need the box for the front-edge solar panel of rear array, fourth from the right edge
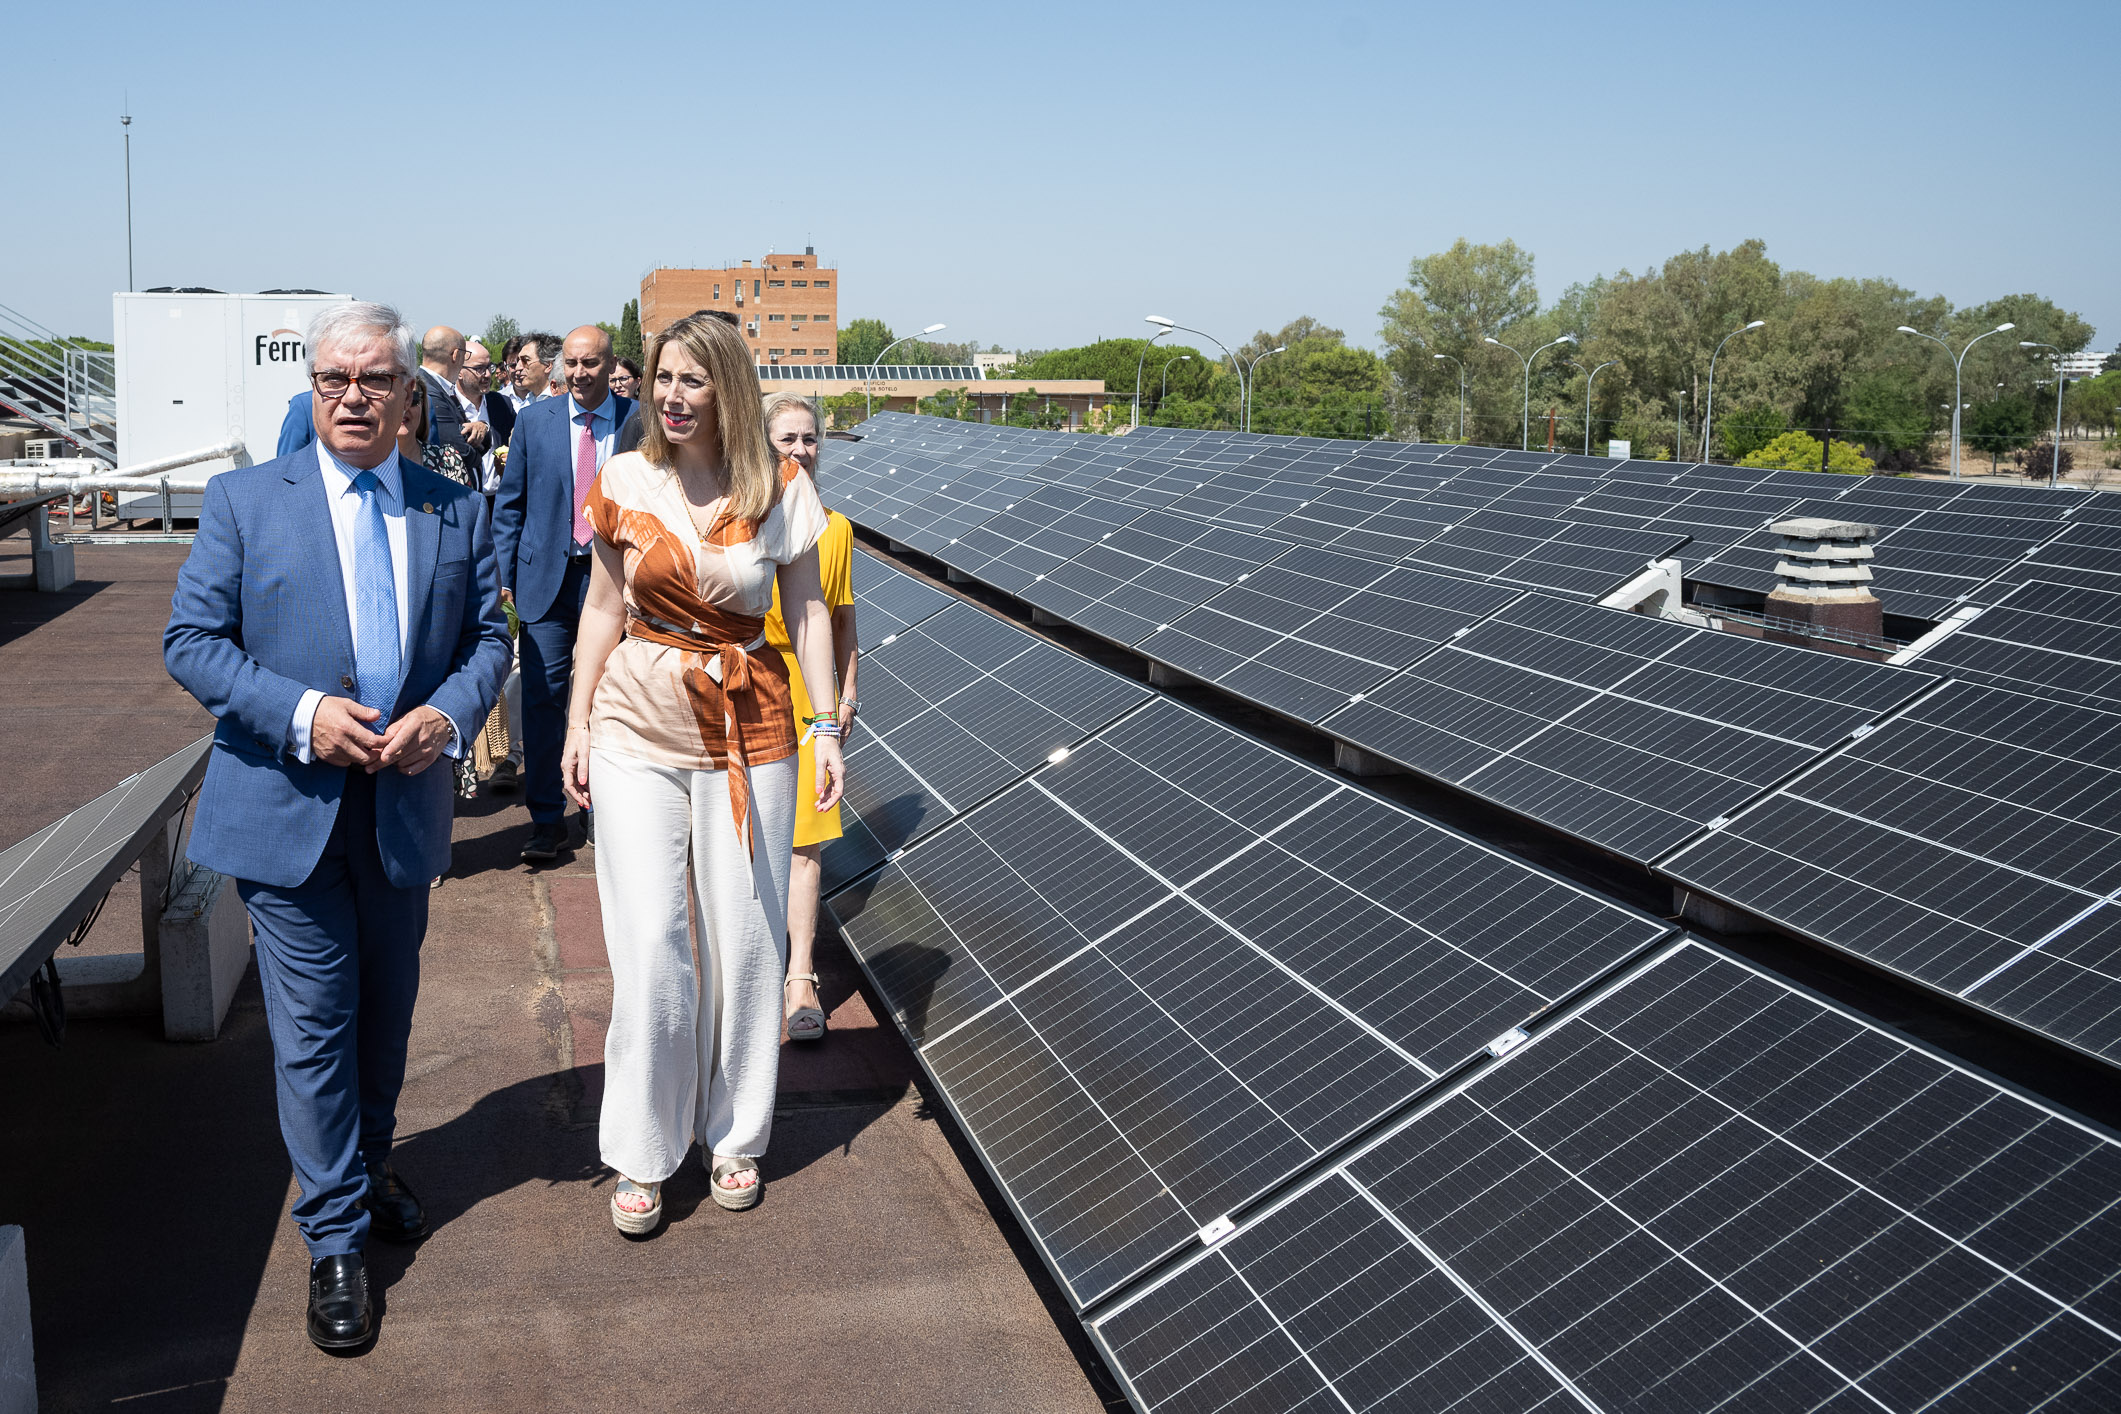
[1020,511,1285,647]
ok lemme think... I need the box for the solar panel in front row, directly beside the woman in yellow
[821,600,1150,890]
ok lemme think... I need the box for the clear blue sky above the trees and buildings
[0,0,2121,348]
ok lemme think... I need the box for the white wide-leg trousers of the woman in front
[590,750,795,1183]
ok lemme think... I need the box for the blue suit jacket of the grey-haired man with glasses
[161,447,509,888]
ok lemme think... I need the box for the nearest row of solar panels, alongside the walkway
[827,558,2121,1412]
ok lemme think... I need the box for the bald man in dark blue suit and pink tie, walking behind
[494,324,634,861]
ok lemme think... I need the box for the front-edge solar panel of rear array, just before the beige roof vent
[1324,594,1936,861]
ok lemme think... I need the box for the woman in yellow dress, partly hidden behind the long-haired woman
[764,392,857,1041]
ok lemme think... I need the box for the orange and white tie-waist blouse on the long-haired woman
[583,452,825,801]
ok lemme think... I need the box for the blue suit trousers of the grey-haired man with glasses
[238,761,426,1257]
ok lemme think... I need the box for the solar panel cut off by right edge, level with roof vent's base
[1917,579,2121,708]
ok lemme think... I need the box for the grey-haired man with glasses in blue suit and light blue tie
[163,303,509,1350]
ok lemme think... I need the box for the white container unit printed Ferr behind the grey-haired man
[110,290,352,519]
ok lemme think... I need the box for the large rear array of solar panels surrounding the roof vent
[825,413,2121,1064]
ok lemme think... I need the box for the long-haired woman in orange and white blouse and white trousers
[560,316,844,1234]
